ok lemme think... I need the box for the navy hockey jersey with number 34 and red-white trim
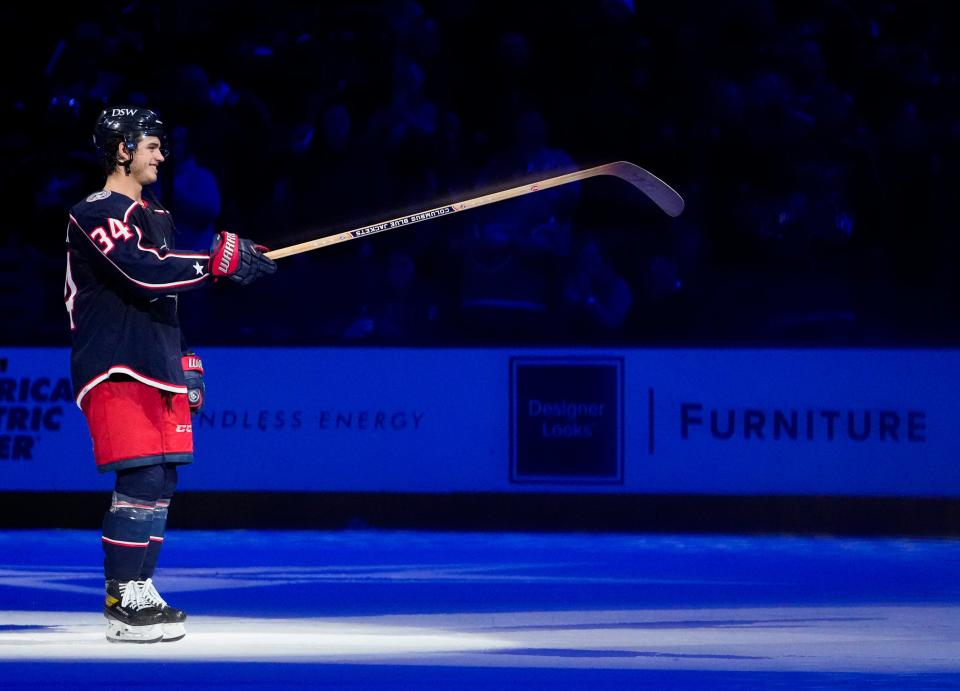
[64,190,210,405]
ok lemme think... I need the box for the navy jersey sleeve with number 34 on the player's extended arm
[67,193,210,296]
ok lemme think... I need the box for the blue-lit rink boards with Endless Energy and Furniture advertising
[0,348,960,497]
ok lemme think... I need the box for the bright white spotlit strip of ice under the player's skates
[0,606,960,673]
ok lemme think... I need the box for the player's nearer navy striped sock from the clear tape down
[101,492,156,582]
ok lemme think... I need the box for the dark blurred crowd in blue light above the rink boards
[0,0,960,346]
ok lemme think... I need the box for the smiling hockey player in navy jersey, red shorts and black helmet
[64,107,276,643]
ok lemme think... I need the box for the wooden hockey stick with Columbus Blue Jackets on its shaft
[266,161,683,259]
